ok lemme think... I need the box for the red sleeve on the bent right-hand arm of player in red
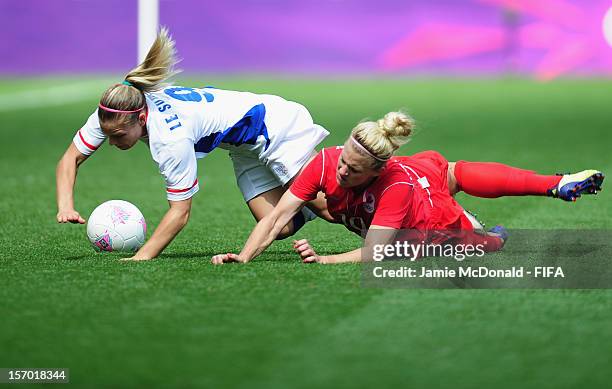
[372,182,413,229]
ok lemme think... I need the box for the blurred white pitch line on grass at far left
[0,79,112,112]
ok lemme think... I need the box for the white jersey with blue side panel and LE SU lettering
[73,86,327,201]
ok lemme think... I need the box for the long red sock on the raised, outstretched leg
[455,161,561,198]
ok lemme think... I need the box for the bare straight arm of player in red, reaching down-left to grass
[211,190,306,265]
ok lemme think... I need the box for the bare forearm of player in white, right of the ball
[128,198,191,261]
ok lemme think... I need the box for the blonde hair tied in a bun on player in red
[351,112,415,166]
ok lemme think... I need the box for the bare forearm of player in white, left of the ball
[55,143,88,224]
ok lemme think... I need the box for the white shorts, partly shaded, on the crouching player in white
[229,122,329,202]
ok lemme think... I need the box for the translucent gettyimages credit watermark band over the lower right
[362,230,612,289]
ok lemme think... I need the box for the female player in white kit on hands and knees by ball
[56,29,329,260]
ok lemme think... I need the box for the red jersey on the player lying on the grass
[290,146,471,236]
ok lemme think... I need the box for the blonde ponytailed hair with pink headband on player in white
[98,28,179,129]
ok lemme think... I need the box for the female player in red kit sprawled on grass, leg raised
[212,112,604,264]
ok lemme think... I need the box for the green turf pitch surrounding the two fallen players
[0,77,612,389]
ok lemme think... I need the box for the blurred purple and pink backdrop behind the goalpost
[0,0,612,79]
